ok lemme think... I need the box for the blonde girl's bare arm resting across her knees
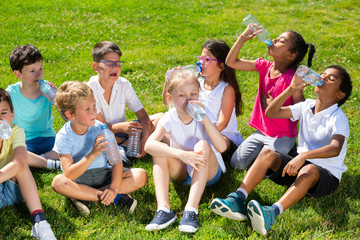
[145,125,207,171]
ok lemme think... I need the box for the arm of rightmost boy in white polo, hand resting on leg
[282,134,345,176]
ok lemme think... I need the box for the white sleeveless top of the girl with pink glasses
[199,77,244,146]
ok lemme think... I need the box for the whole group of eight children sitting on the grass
[0,23,352,239]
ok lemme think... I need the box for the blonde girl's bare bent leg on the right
[185,141,219,209]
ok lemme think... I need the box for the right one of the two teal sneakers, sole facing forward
[247,200,275,235]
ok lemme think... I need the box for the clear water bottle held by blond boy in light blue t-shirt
[101,124,122,166]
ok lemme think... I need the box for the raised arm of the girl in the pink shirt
[225,28,259,71]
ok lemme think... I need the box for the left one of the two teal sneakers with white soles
[210,192,247,221]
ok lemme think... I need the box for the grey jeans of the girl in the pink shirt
[230,130,296,169]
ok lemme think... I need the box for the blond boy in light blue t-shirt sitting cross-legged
[52,81,147,215]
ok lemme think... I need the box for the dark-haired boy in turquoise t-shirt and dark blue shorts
[6,45,60,169]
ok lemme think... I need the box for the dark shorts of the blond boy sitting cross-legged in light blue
[74,168,128,189]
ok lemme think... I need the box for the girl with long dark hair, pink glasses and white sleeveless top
[163,40,243,156]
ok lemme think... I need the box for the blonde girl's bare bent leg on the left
[153,157,187,209]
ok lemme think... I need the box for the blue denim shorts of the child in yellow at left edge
[0,180,24,208]
